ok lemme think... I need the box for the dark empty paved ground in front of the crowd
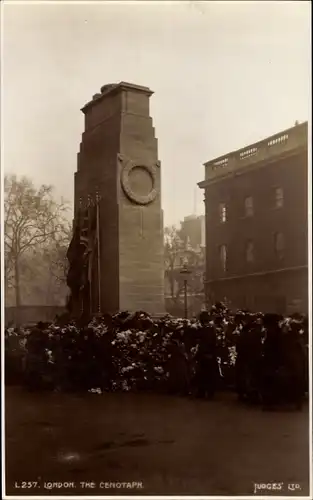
[6,388,309,497]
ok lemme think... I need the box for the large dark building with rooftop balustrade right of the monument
[199,122,308,313]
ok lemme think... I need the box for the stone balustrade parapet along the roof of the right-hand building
[199,122,308,182]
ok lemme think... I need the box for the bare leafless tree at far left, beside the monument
[4,175,69,306]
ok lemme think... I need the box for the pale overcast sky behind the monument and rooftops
[2,1,311,224]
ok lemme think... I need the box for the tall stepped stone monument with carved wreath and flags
[68,82,165,315]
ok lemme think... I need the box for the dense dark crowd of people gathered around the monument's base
[5,303,308,409]
